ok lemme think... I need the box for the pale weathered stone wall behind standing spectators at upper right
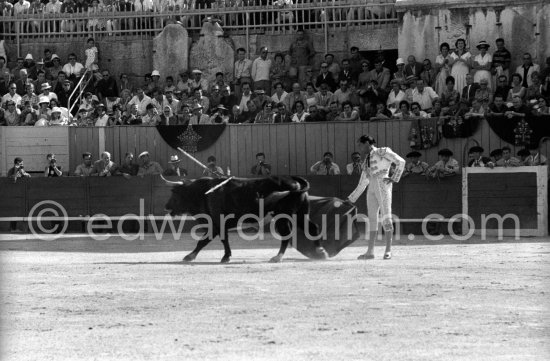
[398,2,550,68]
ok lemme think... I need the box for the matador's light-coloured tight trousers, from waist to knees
[367,176,393,232]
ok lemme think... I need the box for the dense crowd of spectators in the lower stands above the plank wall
[0,35,550,126]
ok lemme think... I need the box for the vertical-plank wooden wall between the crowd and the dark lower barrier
[0,121,550,177]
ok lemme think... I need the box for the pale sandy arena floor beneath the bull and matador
[0,233,550,361]
